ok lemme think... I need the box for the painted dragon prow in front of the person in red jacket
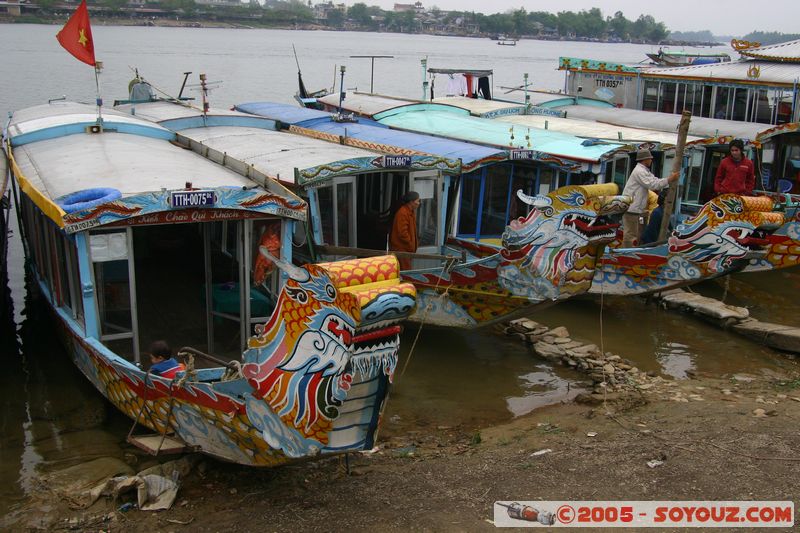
[589,194,784,295]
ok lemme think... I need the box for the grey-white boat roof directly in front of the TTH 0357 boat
[557,105,774,140]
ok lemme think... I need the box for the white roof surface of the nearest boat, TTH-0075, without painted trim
[8,102,257,201]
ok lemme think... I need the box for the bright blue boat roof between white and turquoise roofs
[236,102,508,171]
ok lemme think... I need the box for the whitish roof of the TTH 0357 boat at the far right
[641,60,800,87]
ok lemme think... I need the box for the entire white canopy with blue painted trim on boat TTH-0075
[8,102,305,231]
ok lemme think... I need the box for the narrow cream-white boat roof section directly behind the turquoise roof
[494,115,701,145]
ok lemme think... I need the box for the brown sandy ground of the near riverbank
[4,368,800,532]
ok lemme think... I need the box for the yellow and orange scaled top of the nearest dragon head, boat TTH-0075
[320,255,416,309]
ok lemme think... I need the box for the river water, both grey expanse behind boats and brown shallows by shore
[0,25,800,523]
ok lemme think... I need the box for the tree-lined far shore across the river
[0,0,800,45]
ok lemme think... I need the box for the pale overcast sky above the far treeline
[368,0,800,36]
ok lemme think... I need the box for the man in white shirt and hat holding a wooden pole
[622,150,680,248]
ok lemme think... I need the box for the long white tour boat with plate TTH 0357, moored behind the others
[559,40,800,125]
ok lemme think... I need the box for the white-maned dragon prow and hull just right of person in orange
[402,183,630,327]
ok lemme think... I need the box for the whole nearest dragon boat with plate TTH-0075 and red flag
[3,101,415,466]
